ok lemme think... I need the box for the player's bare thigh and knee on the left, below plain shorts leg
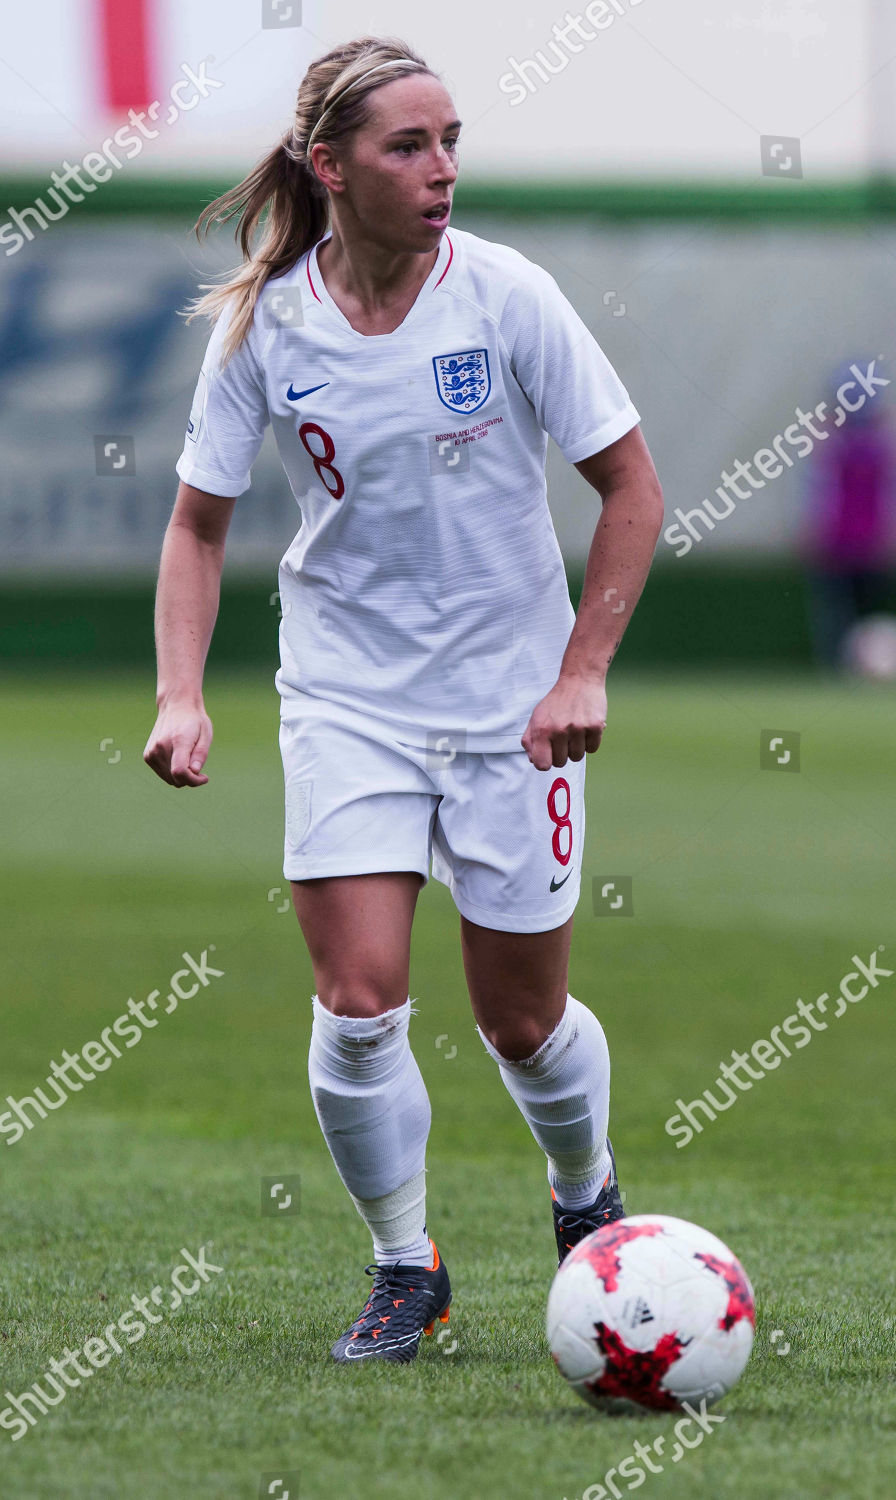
[290,870,423,1016]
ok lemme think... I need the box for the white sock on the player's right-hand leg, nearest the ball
[476,995,611,1209]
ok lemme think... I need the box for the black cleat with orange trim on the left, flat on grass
[330,1241,452,1365]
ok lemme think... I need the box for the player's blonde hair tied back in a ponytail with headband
[185,36,437,363]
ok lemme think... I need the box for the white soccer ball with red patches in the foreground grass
[548,1214,756,1412]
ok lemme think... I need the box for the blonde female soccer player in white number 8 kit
[144,38,662,1364]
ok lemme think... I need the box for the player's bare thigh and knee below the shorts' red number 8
[461,917,573,1062]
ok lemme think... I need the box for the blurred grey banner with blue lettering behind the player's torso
[0,215,896,576]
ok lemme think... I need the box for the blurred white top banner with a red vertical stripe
[0,0,876,182]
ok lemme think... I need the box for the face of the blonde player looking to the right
[342,75,461,251]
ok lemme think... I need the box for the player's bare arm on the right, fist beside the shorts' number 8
[522,428,663,771]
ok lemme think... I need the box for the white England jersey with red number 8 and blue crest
[177,230,639,750]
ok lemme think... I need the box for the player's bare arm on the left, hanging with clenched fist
[143,480,236,786]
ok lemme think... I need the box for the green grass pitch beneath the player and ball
[0,668,896,1500]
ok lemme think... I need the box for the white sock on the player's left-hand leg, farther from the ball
[308,995,432,1266]
